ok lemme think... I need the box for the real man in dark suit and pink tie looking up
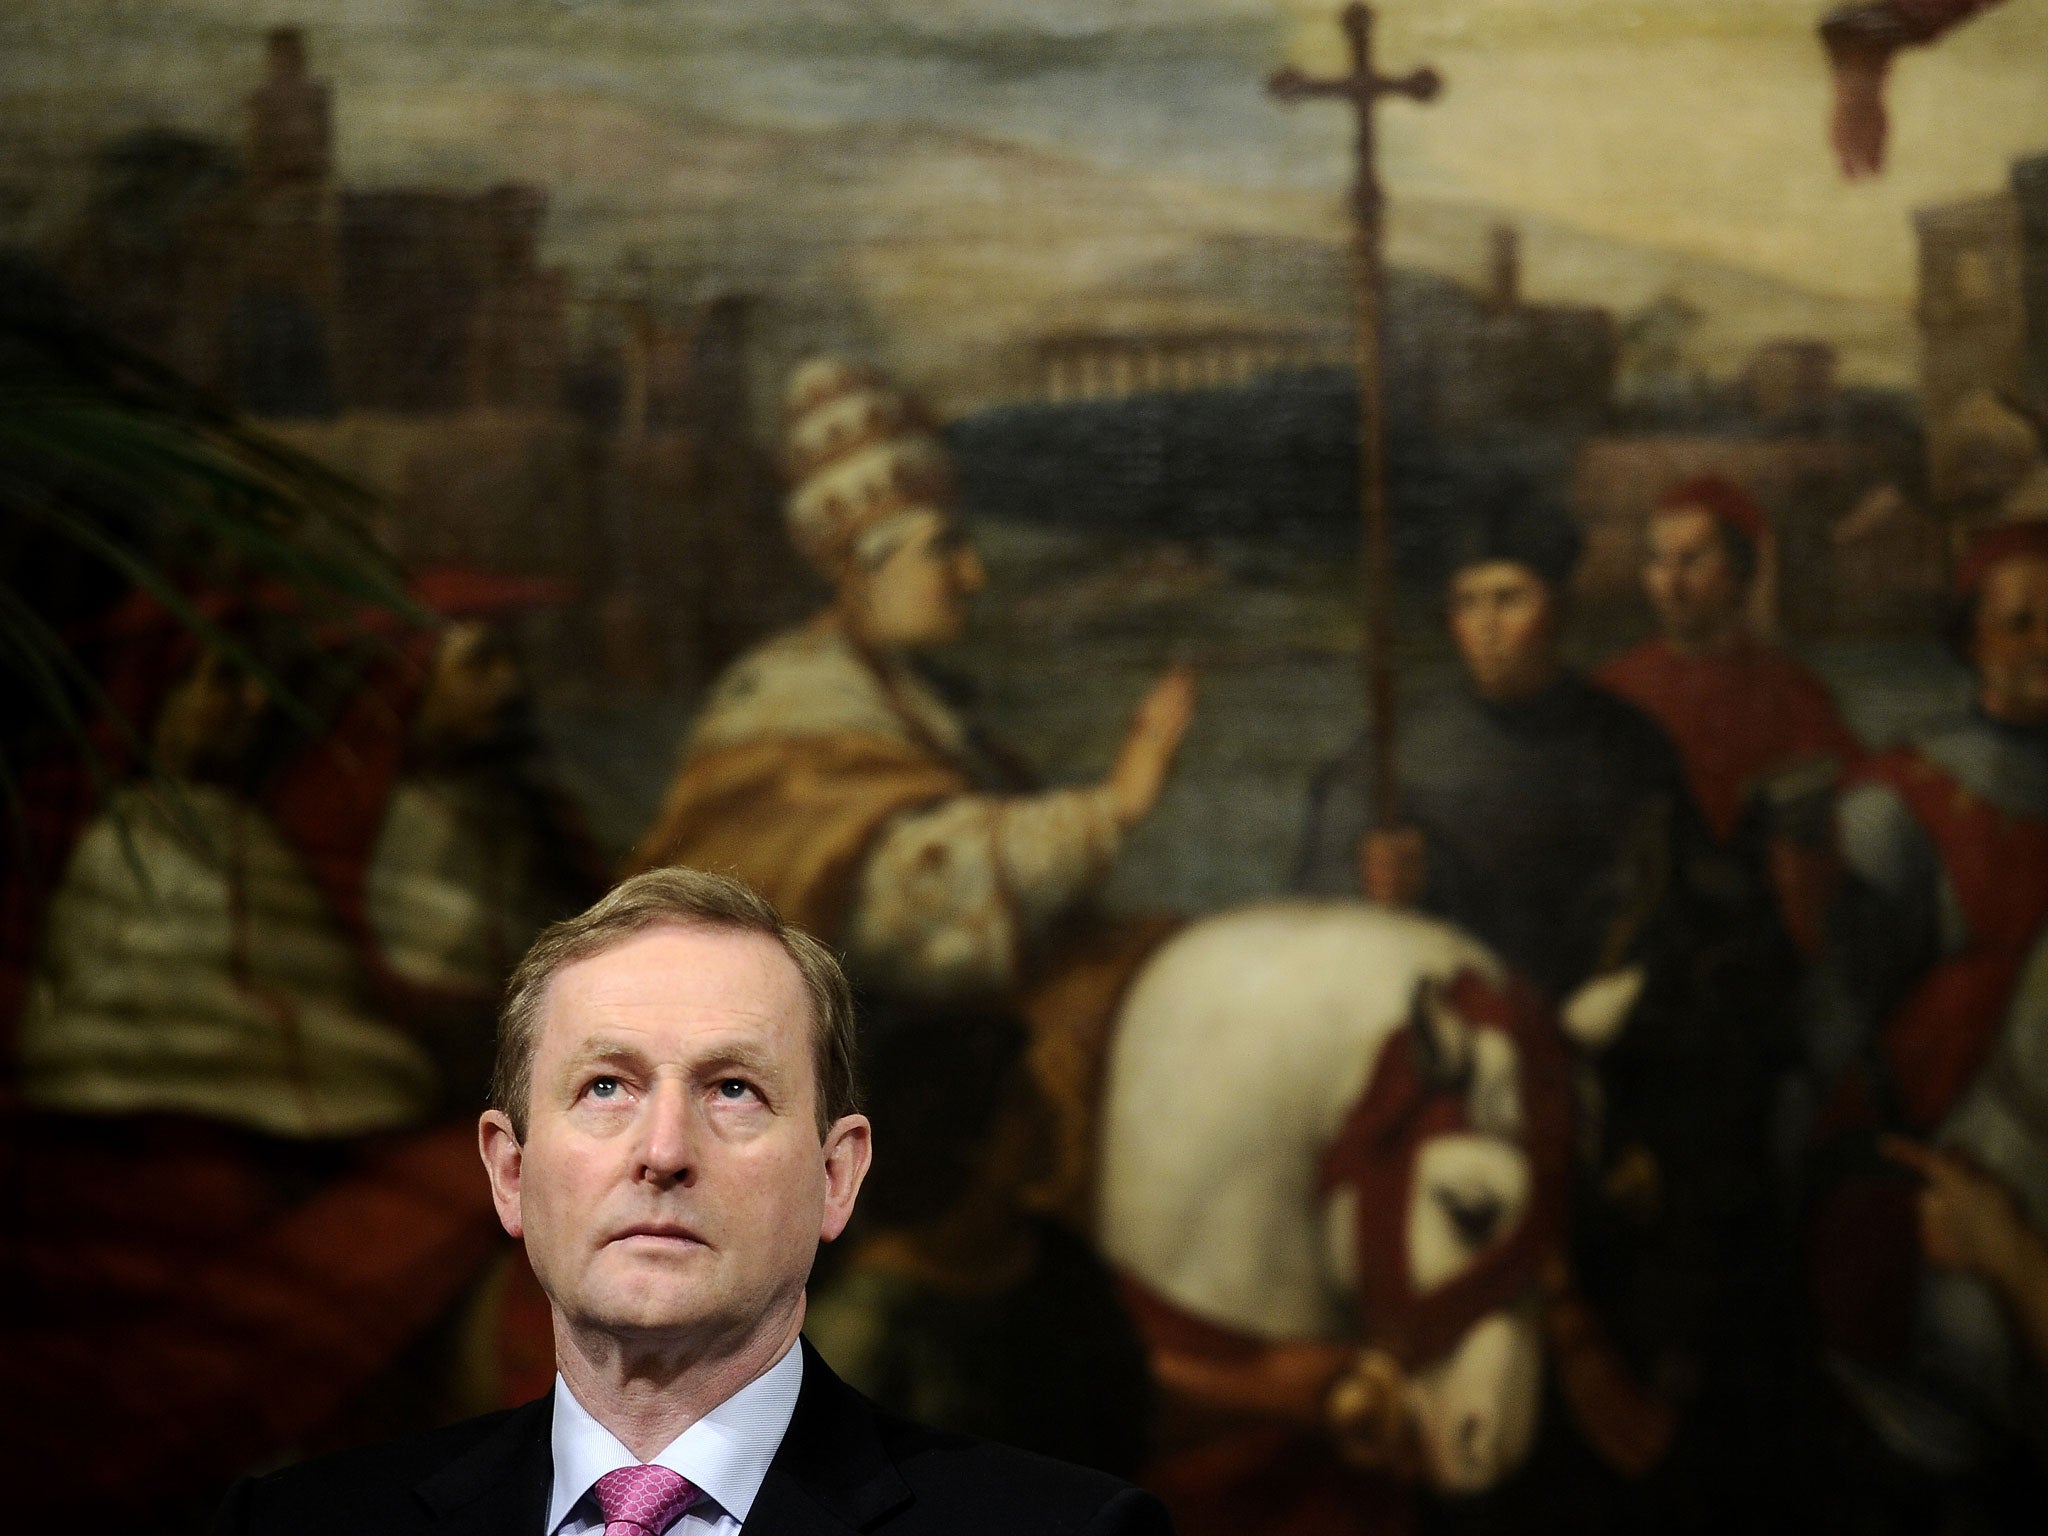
[219,868,1169,1536]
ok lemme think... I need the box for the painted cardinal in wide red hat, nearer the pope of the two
[264,567,604,1106]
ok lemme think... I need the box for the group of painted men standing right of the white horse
[1298,477,2048,1530]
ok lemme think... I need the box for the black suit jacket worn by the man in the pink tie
[215,1341,1171,1536]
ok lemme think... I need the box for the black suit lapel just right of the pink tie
[745,1339,913,1536]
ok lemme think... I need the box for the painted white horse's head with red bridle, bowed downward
[1323,971,1571,1493]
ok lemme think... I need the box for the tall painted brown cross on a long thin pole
[1266,4,1444,827]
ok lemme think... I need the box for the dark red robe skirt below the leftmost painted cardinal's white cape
[0,1114,498,1528]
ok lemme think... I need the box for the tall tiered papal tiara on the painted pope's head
[782,356,952,575]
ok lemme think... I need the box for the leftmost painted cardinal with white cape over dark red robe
[0,598,498,1530]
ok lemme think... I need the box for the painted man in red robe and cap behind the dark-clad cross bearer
[1599,475,1864,952]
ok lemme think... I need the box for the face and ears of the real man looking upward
[481,926,868,1354]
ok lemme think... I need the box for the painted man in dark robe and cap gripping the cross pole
[1298,481,1790,1530]
